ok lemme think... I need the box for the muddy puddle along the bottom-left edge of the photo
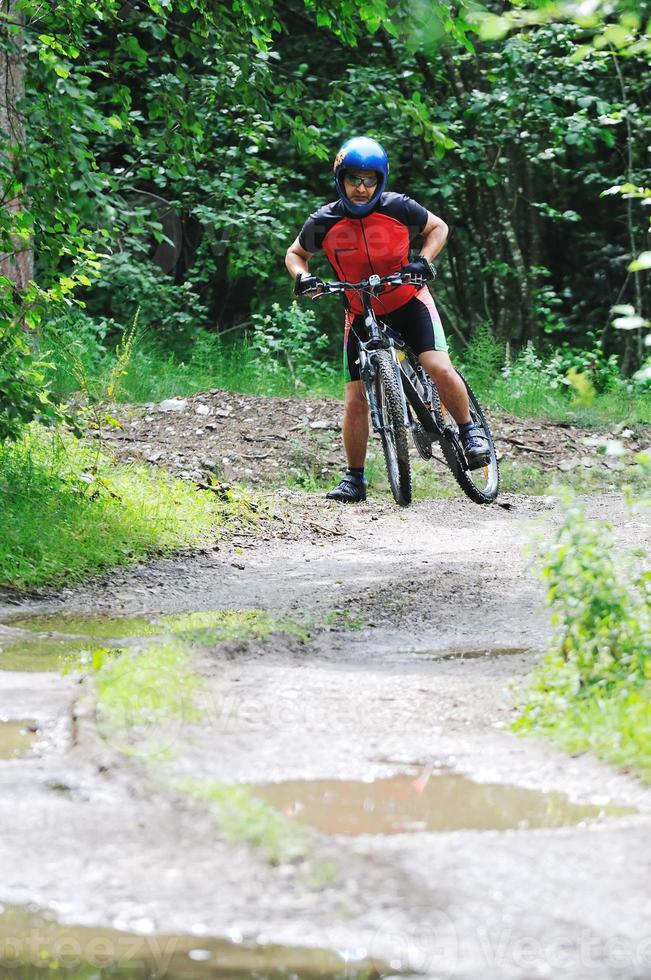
[0,906,388,980]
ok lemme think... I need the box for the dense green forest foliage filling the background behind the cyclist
[0,0,649,437]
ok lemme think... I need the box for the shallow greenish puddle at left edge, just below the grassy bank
[0,609,273,672]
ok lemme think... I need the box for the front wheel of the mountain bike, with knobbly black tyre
[373,351,411,507]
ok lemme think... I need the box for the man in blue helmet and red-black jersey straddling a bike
[285,136,489,503]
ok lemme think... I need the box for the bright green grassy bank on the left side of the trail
[0,429,252,589]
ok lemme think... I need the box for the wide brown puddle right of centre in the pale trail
[248,772,636,836]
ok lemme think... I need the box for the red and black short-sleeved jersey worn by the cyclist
[298,192,427,314]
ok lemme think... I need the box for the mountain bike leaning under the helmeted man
[314,272,500,507]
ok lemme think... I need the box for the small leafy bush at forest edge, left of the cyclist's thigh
[252,302,335,388]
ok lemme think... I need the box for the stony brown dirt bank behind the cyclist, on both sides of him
[97,391,651,486]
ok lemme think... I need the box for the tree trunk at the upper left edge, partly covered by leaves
[0,0,34,290]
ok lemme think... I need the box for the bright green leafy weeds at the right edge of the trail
[514,490,651,782]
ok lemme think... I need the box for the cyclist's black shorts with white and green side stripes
[344,288,448,381]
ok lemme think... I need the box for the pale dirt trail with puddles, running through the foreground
[0,494,651,980]
